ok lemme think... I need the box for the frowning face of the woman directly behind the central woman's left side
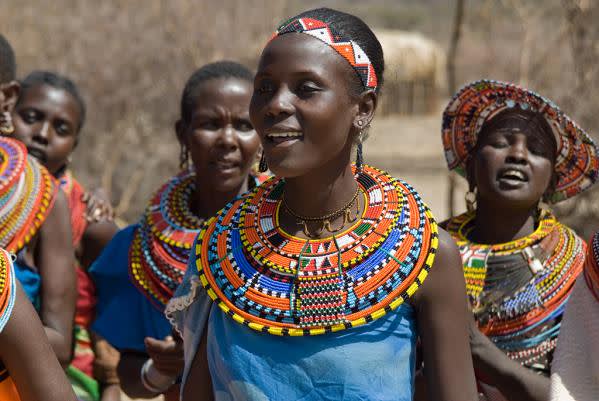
[178,78,260,192]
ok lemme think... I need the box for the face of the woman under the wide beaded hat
[472,125,555,208]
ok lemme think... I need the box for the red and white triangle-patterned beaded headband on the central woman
[271,18,378,90]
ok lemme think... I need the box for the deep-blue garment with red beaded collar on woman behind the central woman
[90,171,266,352]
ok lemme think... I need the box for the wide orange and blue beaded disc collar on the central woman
[192,166,438,336]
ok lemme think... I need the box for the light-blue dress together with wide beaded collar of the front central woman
[166,166,438,400]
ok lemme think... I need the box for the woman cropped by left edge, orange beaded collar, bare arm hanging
[0,37,76,366]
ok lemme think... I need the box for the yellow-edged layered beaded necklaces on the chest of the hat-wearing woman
[447,211,586,373]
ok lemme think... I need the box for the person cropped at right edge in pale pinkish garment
[550,232,599,401]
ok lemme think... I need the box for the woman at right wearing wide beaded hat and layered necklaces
[443,80,599,401]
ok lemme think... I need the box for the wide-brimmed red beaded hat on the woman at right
[442,80,599,203]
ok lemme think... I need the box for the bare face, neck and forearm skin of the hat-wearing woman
[468,122,556,401]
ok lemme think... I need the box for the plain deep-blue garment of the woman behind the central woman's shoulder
[90,224,172,352]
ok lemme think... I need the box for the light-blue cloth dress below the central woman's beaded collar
[167,267,417,401]
